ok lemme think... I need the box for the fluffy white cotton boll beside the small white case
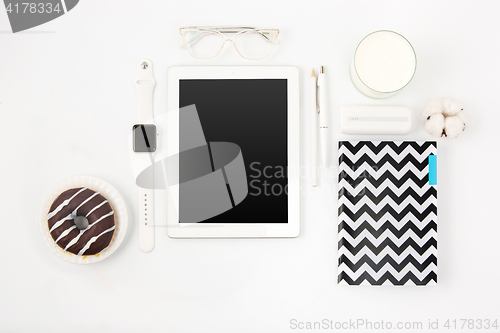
[422,98,470,138]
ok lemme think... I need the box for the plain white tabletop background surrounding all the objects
[0,0,500,332]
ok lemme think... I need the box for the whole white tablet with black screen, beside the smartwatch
[161,66,300,238]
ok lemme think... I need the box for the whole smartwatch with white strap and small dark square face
[132,59,158,252]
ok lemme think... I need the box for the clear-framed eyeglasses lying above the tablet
[180,27,279,60]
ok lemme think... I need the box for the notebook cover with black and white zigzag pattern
[338,141,437,285]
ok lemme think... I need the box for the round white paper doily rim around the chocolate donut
[40,175,128,265]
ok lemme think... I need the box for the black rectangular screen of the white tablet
[179,79,288,223]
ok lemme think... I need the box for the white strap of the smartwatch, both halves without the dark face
[135,59,156,252]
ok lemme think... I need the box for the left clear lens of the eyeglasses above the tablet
[184,31,224,58]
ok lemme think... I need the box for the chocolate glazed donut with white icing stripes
[47,187,115,256]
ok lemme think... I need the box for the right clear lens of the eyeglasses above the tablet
[234,31,274,59]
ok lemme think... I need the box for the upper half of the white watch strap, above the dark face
[135,59,156,124]
